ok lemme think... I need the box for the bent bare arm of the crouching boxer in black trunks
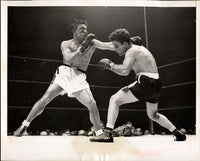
[112,51,135,76]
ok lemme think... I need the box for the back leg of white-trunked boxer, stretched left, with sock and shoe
[14,84,63,136]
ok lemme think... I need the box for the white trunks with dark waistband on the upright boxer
[52,65,90,97]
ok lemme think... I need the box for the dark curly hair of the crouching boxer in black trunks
[109,29,131,44]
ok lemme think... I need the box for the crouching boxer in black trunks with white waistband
[90,29,186,142]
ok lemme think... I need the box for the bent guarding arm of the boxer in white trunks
[61,41,82,62]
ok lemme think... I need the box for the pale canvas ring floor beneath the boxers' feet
[1,135,200,161]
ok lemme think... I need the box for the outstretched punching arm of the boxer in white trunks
[93,39,115,51]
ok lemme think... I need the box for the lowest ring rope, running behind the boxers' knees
[8,106,196,112]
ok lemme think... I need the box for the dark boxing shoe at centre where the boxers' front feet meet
[90,131,114,143]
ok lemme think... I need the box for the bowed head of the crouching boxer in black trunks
[109,29,131,56]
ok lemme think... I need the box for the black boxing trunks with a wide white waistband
[128,73,162,103]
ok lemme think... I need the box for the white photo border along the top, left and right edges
[1,0,200,160]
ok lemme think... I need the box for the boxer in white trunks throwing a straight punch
[14,20,115,137]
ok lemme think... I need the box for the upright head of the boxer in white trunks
[70,19,88,40]
